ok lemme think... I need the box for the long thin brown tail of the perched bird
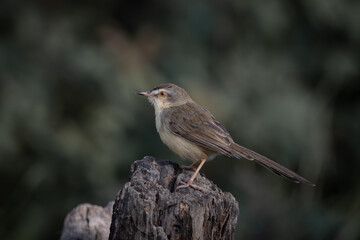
[231,143,315,186]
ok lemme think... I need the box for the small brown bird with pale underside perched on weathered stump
[136,83,315,191]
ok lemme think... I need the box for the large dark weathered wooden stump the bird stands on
[109,157,239,240]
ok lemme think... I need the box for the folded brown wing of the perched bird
[162,102,233,156]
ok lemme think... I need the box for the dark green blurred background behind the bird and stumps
[0,0,360,240]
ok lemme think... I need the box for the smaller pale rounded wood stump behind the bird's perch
[60,202,114,240]
